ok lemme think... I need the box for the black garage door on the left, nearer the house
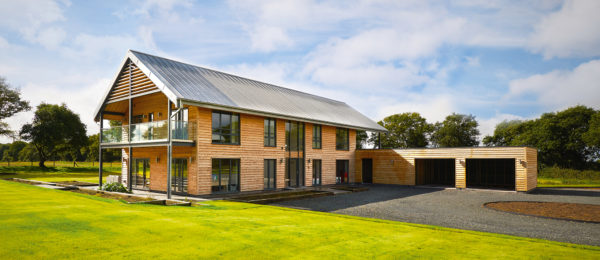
[415,159,455,187]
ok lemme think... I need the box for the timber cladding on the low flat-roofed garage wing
[355,147,537,191]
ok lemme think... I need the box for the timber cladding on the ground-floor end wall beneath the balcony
[123,146,198,194]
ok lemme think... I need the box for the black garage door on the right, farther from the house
[467,159,515,190]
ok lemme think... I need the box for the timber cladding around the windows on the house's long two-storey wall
[189,107,356,194]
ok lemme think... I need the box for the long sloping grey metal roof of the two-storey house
[94,50,387,132]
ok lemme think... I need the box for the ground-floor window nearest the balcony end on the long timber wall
[212,159,240,192]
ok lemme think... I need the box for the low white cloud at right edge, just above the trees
[506,60,600,109]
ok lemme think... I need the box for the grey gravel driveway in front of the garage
[274,185,600,246]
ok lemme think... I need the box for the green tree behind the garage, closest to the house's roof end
[369,113,433,148]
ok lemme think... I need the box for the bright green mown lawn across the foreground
[0,181,600,259]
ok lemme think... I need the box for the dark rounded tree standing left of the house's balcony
[20,103,87,167]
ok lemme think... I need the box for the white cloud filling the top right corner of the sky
[530,0,600,59]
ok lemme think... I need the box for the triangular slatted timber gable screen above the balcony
[108,60,158,103]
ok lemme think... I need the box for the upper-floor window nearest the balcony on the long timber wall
[212,111,240,144]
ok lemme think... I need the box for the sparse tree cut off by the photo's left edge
[0,77,31,135]
